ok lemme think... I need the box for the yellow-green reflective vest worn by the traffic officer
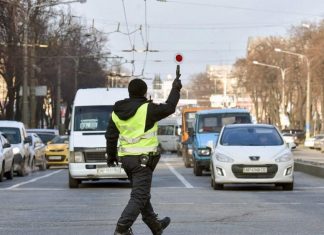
[112,103,159,157]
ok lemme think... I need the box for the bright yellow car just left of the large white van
[45,135,69,169]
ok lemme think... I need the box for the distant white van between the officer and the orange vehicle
[157,117,181,155]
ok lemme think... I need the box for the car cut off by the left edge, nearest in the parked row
[0,133,14,182]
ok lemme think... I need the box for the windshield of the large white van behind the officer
[74,106,112,131]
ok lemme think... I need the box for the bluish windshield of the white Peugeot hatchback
[220,126,284,146]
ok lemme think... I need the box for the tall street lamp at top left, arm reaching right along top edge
[22,0,86,125]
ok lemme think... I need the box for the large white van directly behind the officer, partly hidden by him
[69,88,128,188]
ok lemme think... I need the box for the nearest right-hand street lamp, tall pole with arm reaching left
[275,48,310,138]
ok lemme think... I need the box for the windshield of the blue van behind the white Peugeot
[198,113,251,133]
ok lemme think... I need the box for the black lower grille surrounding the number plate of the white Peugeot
[232,164,278,179]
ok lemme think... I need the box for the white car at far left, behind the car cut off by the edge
[0,121,31,176]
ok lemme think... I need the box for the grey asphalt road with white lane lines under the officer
[0,154,324,235]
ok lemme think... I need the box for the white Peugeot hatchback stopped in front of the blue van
[210,124,294,190]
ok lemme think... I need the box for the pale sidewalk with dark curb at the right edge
[293,146,324,178]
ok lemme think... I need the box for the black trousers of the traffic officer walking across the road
[118,155,160,227]
